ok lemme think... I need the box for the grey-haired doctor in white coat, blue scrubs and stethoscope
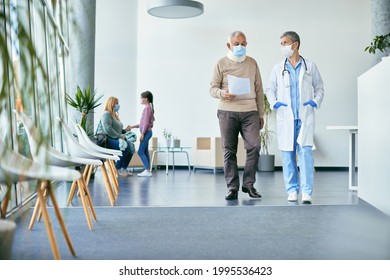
[266,31,324,203]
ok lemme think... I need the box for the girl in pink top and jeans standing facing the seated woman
[138,91,154,177]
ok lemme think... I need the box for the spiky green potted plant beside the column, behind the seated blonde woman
[66,85,103,137]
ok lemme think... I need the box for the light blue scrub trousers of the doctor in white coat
[282,120,314,195]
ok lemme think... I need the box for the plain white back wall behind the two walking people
[96,0,371,166]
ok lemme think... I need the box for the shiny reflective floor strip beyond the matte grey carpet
[56,169,358,207]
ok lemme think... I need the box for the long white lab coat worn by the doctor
[266,59,324,151]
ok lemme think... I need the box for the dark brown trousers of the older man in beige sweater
[217,110,260,190]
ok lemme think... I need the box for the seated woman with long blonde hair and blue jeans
[96,96,135,177]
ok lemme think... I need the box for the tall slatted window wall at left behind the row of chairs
[0,0,69,217]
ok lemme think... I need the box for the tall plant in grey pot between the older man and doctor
[258,95,275,171]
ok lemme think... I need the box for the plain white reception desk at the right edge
[358,57,390,215]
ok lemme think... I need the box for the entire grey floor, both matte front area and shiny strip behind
[8,169,390,260]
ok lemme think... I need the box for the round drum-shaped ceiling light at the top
[148,0,203,19]
